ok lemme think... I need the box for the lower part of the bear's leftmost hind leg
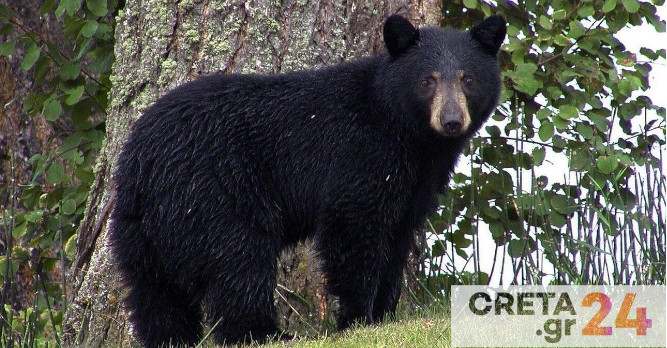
[126,276,203,348]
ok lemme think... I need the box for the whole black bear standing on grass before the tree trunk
[110,15,506,347]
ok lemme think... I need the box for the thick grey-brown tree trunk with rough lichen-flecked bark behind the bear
[64,0,440,347]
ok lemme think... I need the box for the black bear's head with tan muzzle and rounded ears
[380,15,506,137]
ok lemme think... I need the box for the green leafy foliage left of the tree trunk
[0,0,119,347]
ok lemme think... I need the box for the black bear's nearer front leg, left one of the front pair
[315,209,388,330]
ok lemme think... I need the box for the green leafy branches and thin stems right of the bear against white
[420,0,667,302]
